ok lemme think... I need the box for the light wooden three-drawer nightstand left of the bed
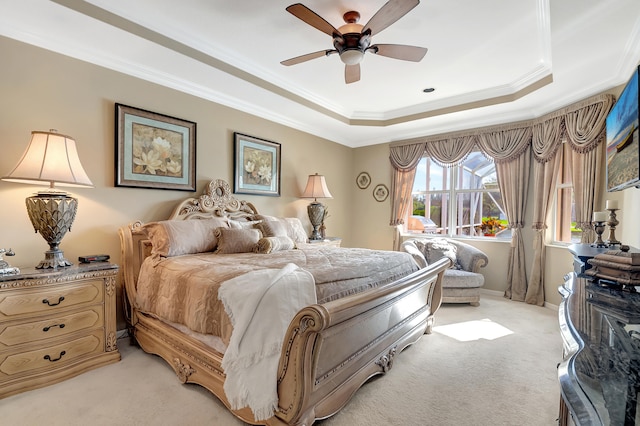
[0,262,120,398]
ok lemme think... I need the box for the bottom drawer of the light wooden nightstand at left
[0,329,104,376]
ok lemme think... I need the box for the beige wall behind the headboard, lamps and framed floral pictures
[0,37,355,327]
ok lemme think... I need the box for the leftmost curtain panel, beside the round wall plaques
[389,143,425,250]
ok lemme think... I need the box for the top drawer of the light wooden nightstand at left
[0,280,104,320]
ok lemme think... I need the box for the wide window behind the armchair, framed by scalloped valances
[409,152,504,238]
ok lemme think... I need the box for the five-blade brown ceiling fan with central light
[280,0,427,84]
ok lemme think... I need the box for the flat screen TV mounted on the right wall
[606,66,640,192]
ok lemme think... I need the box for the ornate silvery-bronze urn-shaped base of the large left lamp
[26,192,78,269]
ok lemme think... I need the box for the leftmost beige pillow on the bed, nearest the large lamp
[142,218,229,257]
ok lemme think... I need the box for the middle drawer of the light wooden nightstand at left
[0,305,104,352]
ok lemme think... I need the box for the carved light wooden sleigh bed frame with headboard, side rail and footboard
[119,181,450,425]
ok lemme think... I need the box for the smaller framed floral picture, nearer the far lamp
[233,132,281,197]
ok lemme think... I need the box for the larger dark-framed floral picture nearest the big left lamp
[115,103,196,191]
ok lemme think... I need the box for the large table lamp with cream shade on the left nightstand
[2,130,93,269]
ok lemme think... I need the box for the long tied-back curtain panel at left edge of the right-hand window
[525,117,563,306]
